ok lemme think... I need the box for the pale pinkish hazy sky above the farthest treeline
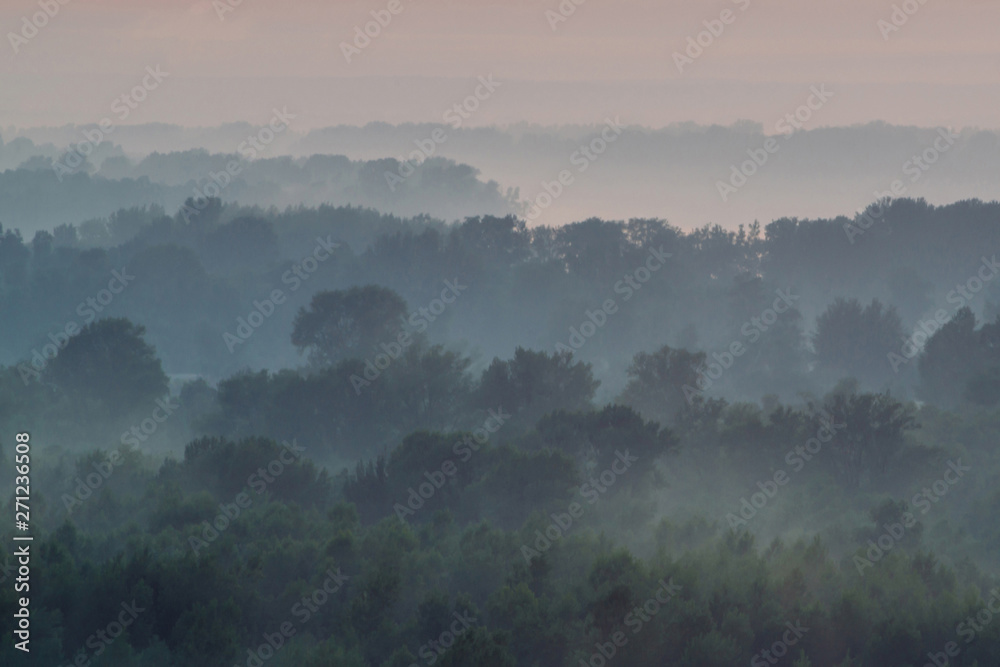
[0,0,1000,129]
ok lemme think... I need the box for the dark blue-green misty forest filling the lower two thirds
[0,200,1000,667]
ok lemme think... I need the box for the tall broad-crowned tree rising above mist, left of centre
[292,285,407,368]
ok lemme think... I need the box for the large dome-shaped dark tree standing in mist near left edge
[45,318,167,415]
